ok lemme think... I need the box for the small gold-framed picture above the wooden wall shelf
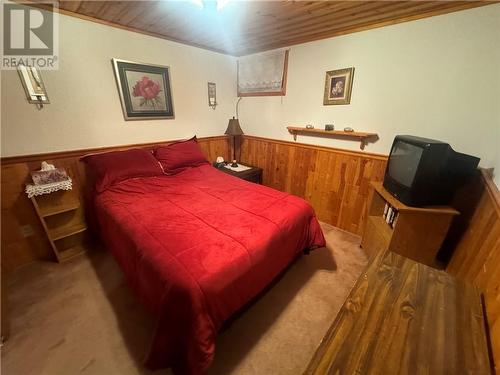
[323,68,354,105]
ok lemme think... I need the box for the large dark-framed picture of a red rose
[112,59,174,120]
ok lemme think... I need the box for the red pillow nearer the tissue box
[81,149,163,193]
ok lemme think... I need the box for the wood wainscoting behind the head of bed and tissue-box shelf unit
[1,136,230,272]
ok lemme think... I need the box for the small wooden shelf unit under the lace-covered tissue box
[31,190,87,262]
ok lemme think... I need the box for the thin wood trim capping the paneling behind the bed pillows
[0,135,228,165]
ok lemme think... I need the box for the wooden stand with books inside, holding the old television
[361,182,460,267]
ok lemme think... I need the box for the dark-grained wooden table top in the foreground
[305,251,492,375]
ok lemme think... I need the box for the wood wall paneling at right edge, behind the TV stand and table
[446,170,500,374]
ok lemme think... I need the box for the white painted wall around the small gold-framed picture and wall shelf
[239,5,500,178]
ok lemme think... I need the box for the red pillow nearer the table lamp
[155,137,208,174]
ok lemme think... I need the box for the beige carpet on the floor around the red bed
[2,224,366,375]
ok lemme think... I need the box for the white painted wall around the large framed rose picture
[1,5,236,156]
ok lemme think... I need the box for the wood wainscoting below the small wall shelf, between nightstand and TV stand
[240,136,387,234]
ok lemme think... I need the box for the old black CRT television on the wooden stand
[384,135,479,207]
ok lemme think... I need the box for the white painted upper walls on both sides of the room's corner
[1,5,500,185]
